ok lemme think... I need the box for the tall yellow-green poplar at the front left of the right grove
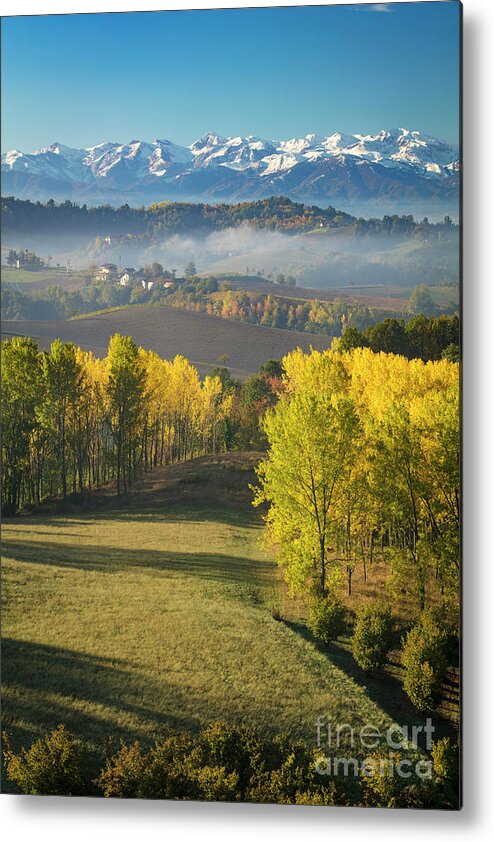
[255,392,358,596]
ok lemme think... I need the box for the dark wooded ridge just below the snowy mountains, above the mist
[2,196,457,238]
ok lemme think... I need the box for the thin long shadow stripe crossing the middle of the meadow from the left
[2,540,273,585]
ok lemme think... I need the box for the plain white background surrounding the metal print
[0,0,494,842]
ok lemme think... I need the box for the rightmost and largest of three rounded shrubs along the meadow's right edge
[401,612,447,712]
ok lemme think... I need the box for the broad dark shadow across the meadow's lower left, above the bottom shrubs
[2,638,205,756]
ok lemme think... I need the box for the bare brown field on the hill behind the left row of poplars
[2,306,331,379]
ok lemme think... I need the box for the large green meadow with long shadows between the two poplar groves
[3,454,452,788]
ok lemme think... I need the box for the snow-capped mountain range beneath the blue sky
[2,129,459,213]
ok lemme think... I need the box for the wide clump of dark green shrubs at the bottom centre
[96,722,346,804]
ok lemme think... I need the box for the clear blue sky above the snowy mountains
[2,2,459,151]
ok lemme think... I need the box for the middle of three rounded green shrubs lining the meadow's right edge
[352,602,393,670]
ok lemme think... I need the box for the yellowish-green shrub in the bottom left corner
[3,725,86,795]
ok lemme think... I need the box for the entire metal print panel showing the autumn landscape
[1,2,461,810]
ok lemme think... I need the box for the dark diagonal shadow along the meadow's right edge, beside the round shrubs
[283,620,456,739]
